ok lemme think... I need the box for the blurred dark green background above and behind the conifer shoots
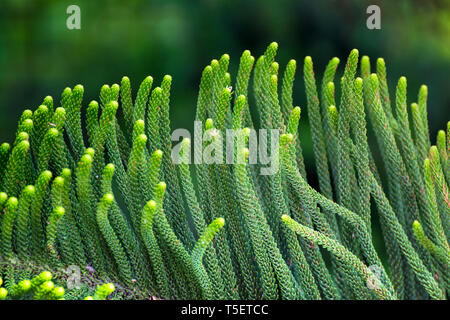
[0,0,450,268]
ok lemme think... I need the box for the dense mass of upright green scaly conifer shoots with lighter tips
[0,43,450,299]
